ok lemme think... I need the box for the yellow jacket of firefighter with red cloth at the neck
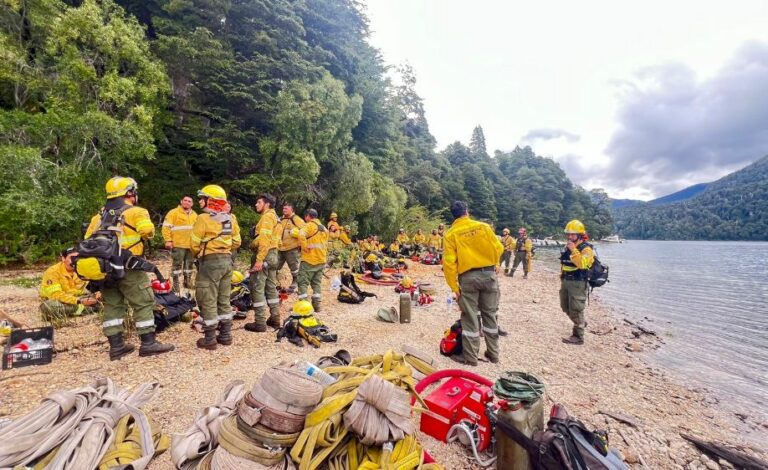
[189,212,242,258]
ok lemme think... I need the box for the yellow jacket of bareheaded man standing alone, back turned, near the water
[443,216,504,292]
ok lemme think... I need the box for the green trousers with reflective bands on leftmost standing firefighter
[101,270,155,336]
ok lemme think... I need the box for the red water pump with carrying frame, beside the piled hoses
[416,369,495,465]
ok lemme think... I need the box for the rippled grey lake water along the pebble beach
[546,240,768,420]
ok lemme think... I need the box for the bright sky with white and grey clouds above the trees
[366,0,768,200]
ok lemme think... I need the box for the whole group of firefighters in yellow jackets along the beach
[40,176,593,365]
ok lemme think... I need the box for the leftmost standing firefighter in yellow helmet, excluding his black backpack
[85,176,174,361]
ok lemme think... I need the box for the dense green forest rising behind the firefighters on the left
[0,0,612,264]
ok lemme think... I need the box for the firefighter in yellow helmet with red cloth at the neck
[190,184,242,350]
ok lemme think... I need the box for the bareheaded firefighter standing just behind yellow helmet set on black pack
[293,209,328,312]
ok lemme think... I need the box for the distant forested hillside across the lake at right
[614,156,768,241]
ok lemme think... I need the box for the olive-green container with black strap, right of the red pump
[496,398,544,470]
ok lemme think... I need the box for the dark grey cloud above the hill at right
[604,42,768,196]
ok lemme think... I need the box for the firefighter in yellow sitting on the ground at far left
[40,248,100,322]
